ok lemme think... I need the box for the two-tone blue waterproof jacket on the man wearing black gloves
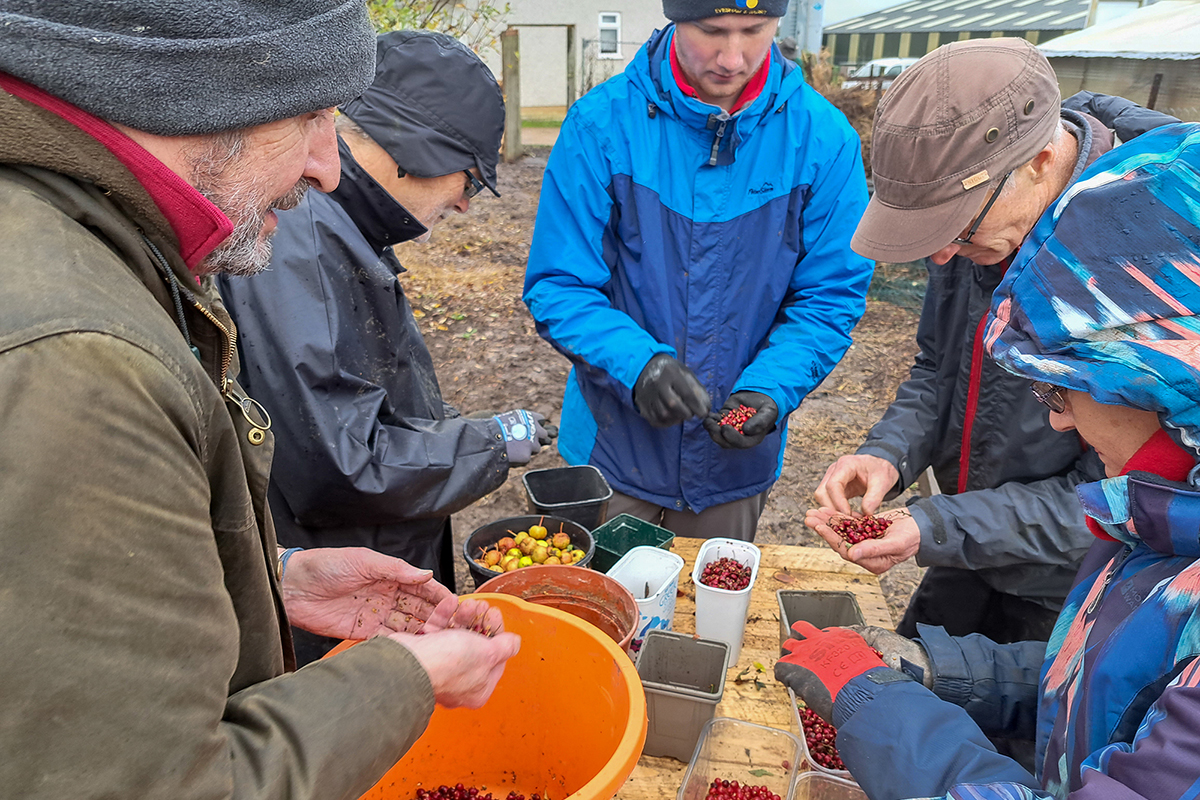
[524,26,872,512]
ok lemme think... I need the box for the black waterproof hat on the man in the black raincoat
[342,30,504,197]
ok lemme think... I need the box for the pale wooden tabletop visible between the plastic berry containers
[617,537,893,800]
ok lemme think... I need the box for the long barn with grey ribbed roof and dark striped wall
[811,0,1092,66]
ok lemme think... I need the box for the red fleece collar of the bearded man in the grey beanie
[0,73,233,270]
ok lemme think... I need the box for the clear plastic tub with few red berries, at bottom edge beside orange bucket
[677,717,803,800]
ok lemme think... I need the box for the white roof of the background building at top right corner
[1036,0,1200,60]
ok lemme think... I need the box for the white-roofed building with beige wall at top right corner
[1039,0,1200,122]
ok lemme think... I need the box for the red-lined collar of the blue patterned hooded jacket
[1075,431,1200,558]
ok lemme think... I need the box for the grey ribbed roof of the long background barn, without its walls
[824,0,1091,34]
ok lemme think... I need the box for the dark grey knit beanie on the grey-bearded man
[0,0,376,136]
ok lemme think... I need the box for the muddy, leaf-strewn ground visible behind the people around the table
[388,149,920,620]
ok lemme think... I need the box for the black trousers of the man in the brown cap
[896,566,1058,644]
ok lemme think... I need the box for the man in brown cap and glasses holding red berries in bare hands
[806,38,1175,642]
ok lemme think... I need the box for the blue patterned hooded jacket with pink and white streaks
[834,125,1200,800]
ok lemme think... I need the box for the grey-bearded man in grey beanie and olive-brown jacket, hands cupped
[0,0,520,800]
